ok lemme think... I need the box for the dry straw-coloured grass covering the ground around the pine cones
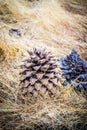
[0,0,87,130]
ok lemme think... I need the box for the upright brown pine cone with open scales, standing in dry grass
[19,49,59,97]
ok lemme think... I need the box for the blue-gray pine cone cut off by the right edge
[59,49,87,90]
